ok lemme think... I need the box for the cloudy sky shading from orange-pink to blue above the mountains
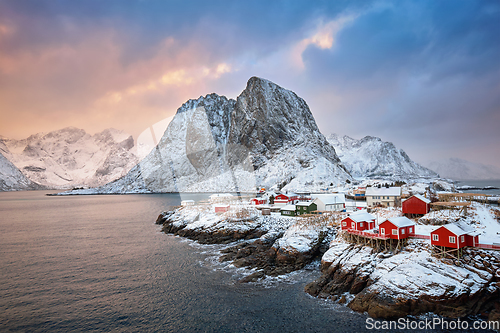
[0,0,500,166]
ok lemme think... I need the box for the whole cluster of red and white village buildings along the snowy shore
[197,187,486,253]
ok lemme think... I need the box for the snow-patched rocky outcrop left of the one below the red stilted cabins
[156,210,336,282]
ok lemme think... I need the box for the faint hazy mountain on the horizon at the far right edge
[428,158,500,180]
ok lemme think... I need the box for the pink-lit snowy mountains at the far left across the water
[0,127,138,188]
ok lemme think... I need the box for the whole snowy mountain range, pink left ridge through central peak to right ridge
[0,77,454,193]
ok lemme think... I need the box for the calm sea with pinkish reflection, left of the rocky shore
[0,191,374,332]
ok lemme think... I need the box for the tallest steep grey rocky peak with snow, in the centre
[78,77,351,193]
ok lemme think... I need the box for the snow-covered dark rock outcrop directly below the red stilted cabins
[306,239,500,318]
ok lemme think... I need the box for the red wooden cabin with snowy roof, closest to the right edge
[431,223,479,249]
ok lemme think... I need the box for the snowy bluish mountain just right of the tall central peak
[328,134,438,179]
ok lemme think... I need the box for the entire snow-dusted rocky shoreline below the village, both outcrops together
[156,206,500,320]
